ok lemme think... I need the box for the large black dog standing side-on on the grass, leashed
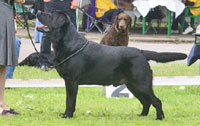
[37,12,187,120]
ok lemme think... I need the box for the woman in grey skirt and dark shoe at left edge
[0,0,25,115]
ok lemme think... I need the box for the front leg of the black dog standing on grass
[63,81,78,118]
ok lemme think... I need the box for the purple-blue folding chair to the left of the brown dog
[79,0,112,34]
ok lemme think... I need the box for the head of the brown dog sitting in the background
[114,13,132,33]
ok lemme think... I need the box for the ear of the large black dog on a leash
[52,11,69,28]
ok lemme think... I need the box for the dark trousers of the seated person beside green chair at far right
[172,10,191,31]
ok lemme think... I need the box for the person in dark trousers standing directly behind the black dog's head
[40,0,79,71]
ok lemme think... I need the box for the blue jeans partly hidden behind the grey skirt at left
[6,37,21,79]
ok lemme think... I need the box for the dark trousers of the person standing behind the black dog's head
[40,3,76,66]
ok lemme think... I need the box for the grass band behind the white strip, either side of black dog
[14,63,199,79]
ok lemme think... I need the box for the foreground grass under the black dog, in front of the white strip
[0,86,200,126]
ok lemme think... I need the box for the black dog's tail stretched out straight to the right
[142,50,187,63]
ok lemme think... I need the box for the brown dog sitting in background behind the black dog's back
[100,13,132,46]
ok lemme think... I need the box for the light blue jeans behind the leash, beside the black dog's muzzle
[34,18,43,43]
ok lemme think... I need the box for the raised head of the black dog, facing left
[37,11,70,31]
